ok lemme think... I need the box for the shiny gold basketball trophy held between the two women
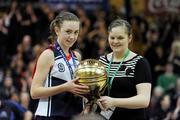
[74,59,107,113]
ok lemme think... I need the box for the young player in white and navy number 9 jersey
[31,12,89,120]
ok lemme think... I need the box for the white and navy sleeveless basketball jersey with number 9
[35,43,82,117]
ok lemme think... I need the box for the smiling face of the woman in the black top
[108,26,132,53]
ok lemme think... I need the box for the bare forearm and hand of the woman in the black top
[98,83,151,109]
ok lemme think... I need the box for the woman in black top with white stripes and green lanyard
[98,19,151,120]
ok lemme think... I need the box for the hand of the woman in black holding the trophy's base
[97,96,114,110]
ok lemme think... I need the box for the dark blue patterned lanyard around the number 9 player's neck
[55,42,76,79]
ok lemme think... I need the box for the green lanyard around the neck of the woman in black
[107,49,130,96]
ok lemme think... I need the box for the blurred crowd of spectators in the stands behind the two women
[0,1,180,120]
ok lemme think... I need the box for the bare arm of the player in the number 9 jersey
[31,50,64,99]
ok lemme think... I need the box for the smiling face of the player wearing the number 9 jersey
[56,21,80,48]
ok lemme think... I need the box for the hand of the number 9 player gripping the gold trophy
[65,78,90,96]
